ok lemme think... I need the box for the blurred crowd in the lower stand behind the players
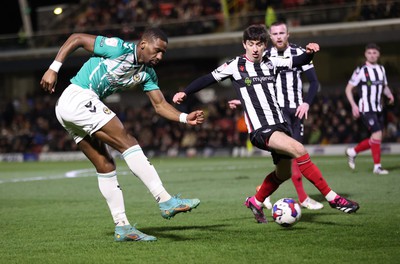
[0,91,400,156]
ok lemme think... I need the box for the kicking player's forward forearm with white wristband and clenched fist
[146,90,204,126]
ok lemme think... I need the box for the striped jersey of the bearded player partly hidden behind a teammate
[266,43,314,108]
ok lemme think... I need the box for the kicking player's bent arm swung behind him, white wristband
[40,33,96,93]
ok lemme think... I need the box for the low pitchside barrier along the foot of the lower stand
[0,143,400,162]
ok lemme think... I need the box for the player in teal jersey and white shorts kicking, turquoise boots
[40,28,204,241]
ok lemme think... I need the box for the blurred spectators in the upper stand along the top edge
[48,0,400,39]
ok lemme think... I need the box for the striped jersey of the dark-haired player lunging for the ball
[212,56,292,133]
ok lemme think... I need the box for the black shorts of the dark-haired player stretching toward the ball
[250,123,292,165]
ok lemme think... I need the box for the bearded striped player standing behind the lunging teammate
[258,21,323,210]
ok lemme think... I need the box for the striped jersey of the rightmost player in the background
[349,64,388,113]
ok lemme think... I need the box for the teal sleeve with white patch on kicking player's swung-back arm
[94,36,129,58]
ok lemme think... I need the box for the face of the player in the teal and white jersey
[138,39,167,67]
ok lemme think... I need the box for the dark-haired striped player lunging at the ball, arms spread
[173,25,359,223]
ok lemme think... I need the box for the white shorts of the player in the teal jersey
[56,84,115,143]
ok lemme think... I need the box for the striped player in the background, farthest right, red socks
[346,43,394,175]
